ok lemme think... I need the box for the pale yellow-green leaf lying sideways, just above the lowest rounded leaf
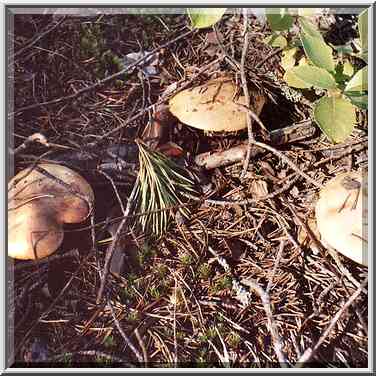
[283,65,337,89]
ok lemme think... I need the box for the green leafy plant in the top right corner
[266,9,368,143]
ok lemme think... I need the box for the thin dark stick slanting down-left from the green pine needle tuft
[96,178,139,304]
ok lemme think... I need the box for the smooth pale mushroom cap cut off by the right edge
[315,172,368,266]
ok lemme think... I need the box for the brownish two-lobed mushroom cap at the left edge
[8,163,94,260]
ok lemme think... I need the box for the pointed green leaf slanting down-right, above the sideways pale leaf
[300,32,334,72]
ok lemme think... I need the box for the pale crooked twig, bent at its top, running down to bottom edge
[241,279,287,368]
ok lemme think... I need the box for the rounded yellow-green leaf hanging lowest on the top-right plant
[314,96,356,143]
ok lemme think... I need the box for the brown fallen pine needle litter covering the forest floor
[11,8,368,368]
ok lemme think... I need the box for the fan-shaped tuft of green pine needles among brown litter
[135,140,200,238]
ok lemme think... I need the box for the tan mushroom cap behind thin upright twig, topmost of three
[169,77,265,132]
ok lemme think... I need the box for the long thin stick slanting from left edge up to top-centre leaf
[9,29,195,117]
